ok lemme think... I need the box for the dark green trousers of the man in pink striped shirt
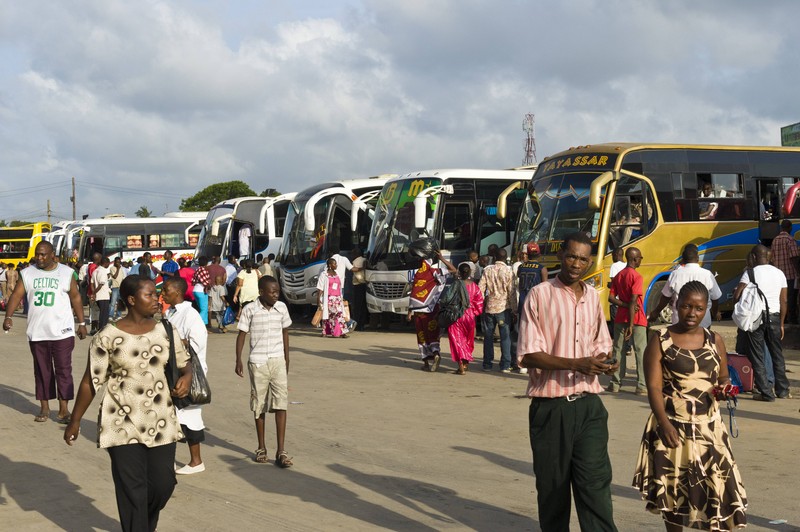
[528,394,617,532]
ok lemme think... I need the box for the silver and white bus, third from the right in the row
[276,176,396,305]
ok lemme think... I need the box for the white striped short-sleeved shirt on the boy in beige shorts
[237,299,292,364]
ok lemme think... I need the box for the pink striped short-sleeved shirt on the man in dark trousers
[517,277,611,397]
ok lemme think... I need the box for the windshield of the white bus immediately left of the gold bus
[369,179,442,270]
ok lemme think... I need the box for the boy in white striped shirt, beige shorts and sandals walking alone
[236,275,293,468]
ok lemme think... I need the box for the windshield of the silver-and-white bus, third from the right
[279,196,333,268]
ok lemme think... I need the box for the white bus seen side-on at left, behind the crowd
[60,212,207,264]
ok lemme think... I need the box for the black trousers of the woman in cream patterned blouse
[108,443,176,532]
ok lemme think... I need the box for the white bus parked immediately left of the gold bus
[365,169,533,314]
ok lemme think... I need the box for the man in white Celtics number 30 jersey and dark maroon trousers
[3,242,86,424]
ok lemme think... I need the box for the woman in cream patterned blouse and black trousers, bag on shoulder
[64,275,192,532]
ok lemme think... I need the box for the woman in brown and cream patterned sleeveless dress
[633,281,747,532]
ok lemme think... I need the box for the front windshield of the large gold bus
[515,172,600,253]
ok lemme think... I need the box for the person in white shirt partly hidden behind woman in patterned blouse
[162,277,208,475]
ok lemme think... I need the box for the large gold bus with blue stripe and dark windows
[515,143,800,320]
